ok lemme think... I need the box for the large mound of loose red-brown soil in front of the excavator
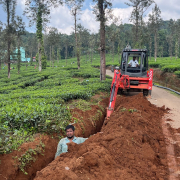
[35,94,168,180]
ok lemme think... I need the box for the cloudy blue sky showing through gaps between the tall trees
[0,0,180,34]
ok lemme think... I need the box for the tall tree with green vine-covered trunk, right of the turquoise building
[24,0,62,71]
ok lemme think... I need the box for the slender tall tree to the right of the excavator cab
[149,4,162,62]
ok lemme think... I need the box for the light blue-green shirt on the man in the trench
[55,136,88,158]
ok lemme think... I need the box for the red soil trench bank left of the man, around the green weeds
[0,135,57,180]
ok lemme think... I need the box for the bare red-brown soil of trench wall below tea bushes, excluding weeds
[0,95,108,180]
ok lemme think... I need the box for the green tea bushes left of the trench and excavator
[0,59,112,153]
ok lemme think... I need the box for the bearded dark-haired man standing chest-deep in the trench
[55,125,88,158]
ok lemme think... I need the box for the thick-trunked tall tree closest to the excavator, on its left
[93,0,112,81]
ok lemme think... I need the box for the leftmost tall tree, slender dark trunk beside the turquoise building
[0,0,16,78]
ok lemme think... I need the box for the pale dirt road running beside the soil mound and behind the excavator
[106,70,180,129]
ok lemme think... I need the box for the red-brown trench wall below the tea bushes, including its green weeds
[0,94,108,180]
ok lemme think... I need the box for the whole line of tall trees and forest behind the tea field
[0,0,180,80]
